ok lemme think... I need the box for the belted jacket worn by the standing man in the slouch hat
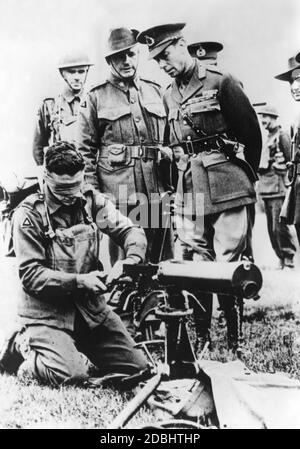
[77,76,170,203]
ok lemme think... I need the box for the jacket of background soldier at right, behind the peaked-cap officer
[258,126,291,198]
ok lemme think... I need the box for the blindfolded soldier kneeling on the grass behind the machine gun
[0,141,147,386]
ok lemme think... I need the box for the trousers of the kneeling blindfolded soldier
[15,308,147,386]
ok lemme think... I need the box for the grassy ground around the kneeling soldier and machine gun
[0,212,300,429]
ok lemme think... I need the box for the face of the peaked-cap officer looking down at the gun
[154,40,185,78]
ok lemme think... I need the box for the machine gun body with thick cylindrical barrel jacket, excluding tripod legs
[108,260,262,340]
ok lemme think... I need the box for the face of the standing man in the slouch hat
[109,46,138,79]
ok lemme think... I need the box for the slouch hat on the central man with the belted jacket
[105,28,139,59]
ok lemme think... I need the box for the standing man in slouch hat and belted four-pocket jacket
[77,27,173,262]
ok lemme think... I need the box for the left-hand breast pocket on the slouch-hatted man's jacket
[98,105,133,145]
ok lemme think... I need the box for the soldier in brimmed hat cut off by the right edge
[275,52,300,248]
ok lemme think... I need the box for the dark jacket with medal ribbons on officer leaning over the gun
[164,61,262,215]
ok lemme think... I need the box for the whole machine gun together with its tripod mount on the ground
[109,260,262,429]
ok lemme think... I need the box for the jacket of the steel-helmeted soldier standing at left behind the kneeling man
[33,88,82,165]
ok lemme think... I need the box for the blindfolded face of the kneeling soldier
[49,170,83,206]
